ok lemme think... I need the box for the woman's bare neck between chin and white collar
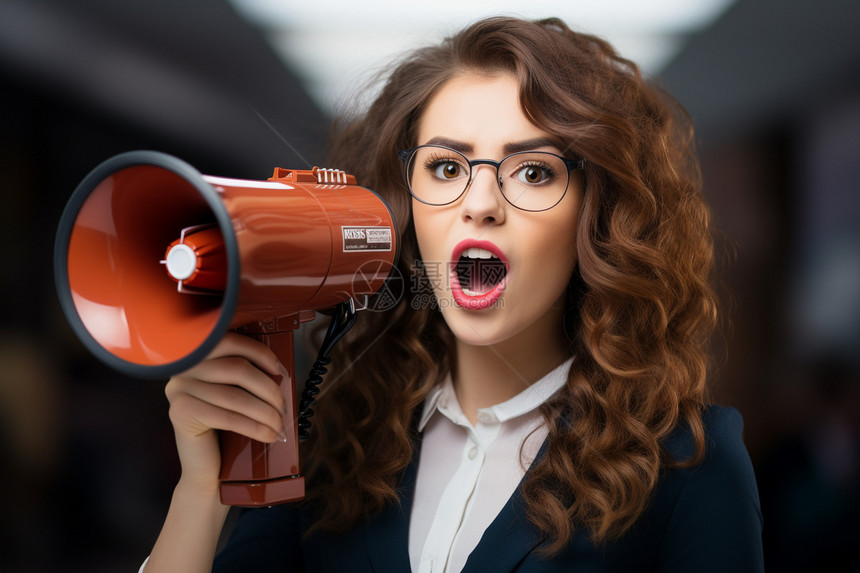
[453,316,567,424]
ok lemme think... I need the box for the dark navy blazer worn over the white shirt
[213,406,764,573]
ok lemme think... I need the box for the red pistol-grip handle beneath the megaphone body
[221,330,305,506]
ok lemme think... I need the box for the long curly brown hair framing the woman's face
[304,17,717,553]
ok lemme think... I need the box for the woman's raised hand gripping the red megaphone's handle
[165,332,285,492]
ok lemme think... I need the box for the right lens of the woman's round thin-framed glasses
[499,151,569,211]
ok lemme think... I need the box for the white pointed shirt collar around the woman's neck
[418,358,573,432]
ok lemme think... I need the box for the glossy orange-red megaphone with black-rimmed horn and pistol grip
[54,151,399,505]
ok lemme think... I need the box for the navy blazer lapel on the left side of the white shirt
[364,440,421,573]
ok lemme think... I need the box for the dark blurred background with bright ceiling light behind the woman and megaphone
[0,0,860,572]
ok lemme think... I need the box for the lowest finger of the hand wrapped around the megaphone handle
[170,394,281,443]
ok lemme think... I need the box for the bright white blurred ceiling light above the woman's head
[230,0,734,113]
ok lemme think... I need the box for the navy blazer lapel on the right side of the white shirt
[463,440,547,573]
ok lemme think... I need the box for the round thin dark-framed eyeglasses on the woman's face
[397,145,585,211]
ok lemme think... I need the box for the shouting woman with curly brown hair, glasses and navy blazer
[146,18,763,572]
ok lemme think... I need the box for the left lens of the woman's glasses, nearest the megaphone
[406,145,469,205]
